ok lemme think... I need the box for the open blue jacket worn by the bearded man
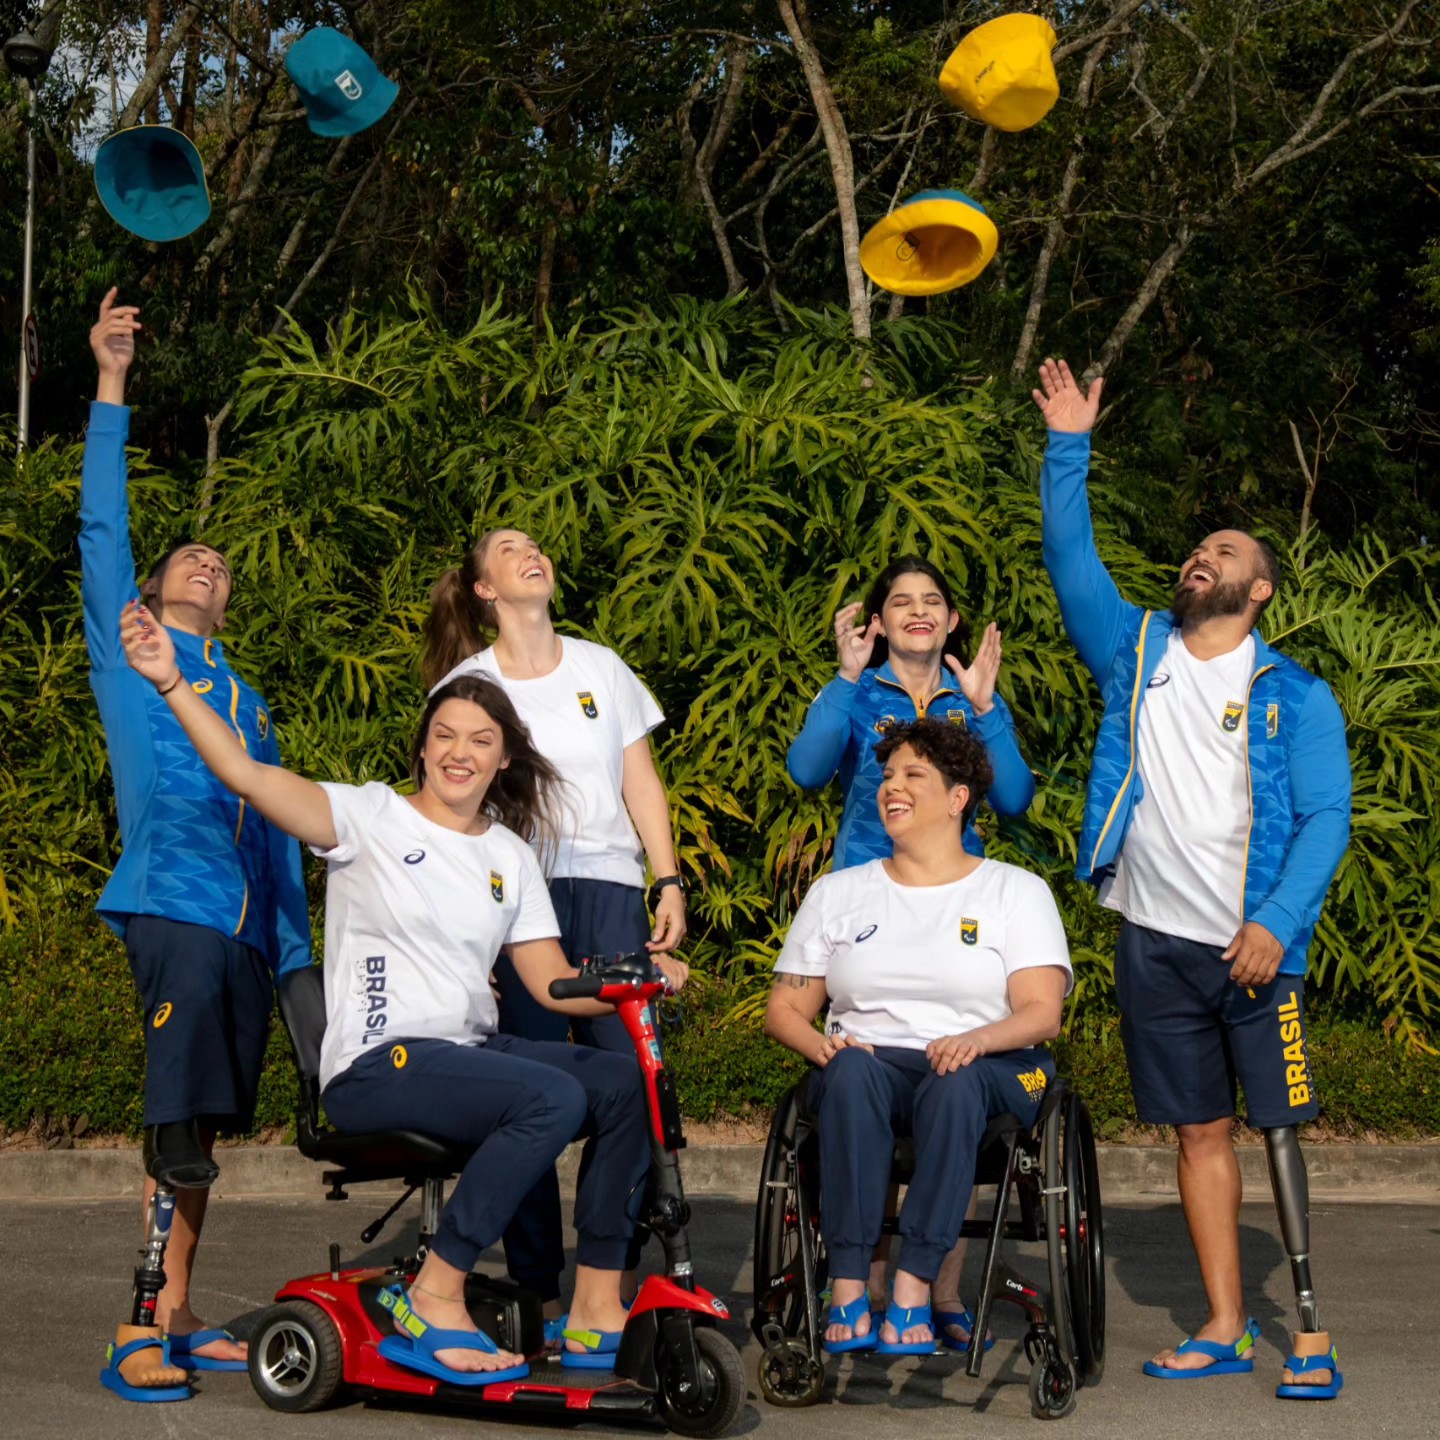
[1040,432,1351,975]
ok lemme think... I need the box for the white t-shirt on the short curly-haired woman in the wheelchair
[775,860,1071,1050]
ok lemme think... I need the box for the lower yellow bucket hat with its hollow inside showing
[860,190,999,295]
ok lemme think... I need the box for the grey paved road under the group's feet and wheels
[14,1197,1440,1440]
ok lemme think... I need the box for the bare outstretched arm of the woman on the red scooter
[120,600,338,850]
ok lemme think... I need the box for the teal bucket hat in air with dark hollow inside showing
[95,125,210,240]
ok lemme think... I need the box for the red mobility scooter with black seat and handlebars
[249,955,744,1437]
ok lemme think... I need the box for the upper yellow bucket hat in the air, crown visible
[940,14,1060,130]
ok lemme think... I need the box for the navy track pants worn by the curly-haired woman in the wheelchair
[809,1048,1054,1280]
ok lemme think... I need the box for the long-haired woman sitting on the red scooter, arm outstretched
[121,603,685,1384]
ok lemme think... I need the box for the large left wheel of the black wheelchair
[750,1081,825,1344]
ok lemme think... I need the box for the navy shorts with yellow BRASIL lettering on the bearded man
[1115,922,1319,1130]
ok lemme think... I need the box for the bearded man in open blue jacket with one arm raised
[1034,360,1351,1400]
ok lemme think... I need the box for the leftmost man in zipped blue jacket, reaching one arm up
[79,289,310,1400]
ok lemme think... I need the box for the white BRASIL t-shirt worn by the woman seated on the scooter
[311,783,560,1089]
